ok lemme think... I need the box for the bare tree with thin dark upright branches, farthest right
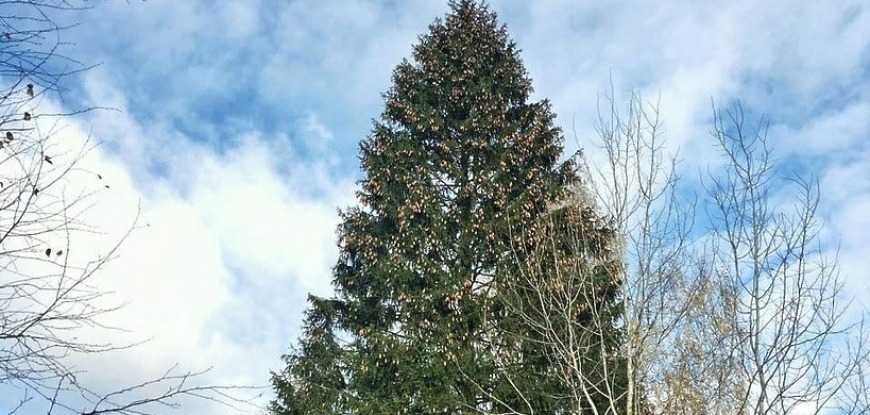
[701,105,867,414]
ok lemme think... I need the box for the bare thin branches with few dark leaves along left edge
[0,0,252,415]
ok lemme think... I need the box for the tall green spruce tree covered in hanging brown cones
[272,0,628,415]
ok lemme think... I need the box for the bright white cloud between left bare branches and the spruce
[1,75,353,413]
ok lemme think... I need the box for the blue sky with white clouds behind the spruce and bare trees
[3,0,870,414]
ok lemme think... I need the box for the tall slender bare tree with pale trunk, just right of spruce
[584,89,699,414]
